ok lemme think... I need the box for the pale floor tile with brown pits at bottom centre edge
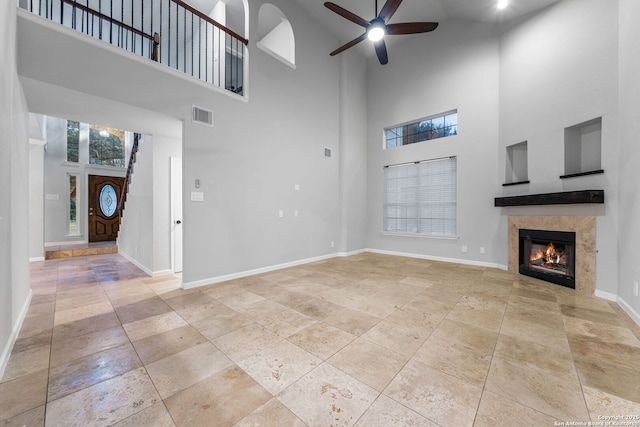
[276,363,379,426]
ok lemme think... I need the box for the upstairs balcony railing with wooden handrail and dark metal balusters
[20,0,248,95]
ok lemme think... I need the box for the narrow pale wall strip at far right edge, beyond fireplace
[617,0,640,324]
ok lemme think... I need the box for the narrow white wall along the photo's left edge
[0,2,31,378]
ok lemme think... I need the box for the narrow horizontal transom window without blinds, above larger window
[385,110,458,148]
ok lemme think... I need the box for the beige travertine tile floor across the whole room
[0,254,640,427]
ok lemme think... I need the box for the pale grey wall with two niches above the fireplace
[497,0,619,295]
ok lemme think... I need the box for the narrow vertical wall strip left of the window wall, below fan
[338,52,367,253]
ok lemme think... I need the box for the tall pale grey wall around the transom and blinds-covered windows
[367,21,506,264]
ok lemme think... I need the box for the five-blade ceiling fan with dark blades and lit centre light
[324,0,438,65]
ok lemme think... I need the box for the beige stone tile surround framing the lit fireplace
[507,216,596,295]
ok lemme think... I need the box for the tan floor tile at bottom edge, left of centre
[165,366,272,427]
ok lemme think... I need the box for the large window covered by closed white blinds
[383,157,457,237]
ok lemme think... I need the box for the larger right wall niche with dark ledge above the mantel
[560,117,604,178]
